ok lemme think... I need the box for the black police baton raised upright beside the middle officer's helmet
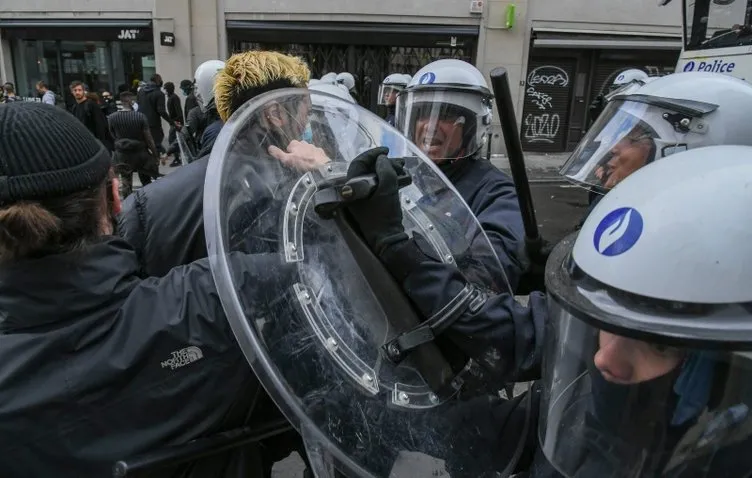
[491,67,546,289]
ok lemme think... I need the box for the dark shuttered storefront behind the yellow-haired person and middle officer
[227,20,479,113]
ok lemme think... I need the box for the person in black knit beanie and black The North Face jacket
[0,102,280,478]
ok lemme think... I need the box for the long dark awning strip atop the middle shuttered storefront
[227,20,480,47]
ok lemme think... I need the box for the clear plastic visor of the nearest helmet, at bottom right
[539,295,752,478]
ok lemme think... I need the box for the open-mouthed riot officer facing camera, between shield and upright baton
[396,60,527,289]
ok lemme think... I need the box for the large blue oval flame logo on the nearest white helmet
[593,207,644,257]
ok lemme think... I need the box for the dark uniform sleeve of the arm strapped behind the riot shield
[382,239,546,384]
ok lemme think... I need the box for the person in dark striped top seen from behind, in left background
[107,91,159,199]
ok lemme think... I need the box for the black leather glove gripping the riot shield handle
[347,147,408,257]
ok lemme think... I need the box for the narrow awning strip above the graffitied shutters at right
[533,30,682,50]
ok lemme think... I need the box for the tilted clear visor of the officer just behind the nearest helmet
[560,100,686,192]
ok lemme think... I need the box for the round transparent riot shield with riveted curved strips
[204,89,521,477]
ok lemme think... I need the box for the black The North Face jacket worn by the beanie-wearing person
[0,237,280,478]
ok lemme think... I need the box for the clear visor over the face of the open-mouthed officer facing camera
[397,90,490,163]
